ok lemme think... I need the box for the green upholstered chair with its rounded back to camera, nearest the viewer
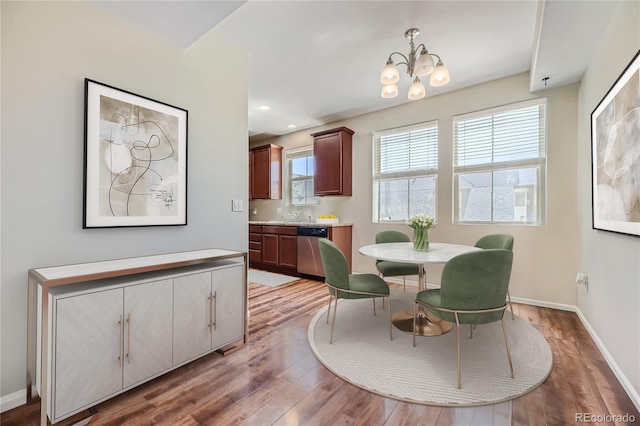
[413,249,514,389]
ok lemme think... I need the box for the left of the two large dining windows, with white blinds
[373,121,438,223]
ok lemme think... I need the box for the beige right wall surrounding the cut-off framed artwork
[577,1,640,408]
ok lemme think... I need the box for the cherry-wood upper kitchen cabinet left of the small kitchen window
[249,145,282,200]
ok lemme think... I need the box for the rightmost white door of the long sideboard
[211,264,246,349]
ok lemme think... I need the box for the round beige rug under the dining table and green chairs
[308,289,553,406]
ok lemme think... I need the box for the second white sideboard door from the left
[124,279,173,388]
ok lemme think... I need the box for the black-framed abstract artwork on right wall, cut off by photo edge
[591,51,640,236]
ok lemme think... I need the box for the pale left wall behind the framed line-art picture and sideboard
[0,2,248,397]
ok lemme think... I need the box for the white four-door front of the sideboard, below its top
[39,261,247,423]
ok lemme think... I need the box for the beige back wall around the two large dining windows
[250,73,578,306]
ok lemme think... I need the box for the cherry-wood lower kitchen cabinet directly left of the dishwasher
[262,226,298,272]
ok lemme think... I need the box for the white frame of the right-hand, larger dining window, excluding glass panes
[452,98,547,226]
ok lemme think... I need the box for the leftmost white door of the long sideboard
[52,288,124,419]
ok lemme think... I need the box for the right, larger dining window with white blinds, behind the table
[453,99,546,225]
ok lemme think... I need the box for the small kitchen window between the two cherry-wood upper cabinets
[286,147,320,206]
